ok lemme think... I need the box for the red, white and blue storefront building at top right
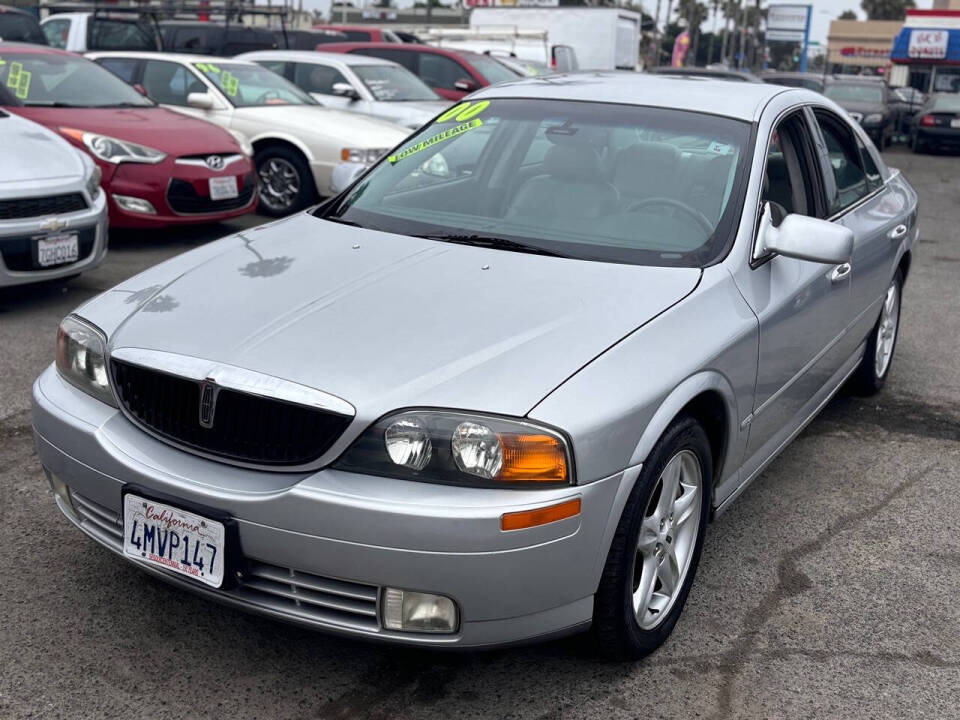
[890,10,960,93]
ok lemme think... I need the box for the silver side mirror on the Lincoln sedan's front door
[754,203,853,265]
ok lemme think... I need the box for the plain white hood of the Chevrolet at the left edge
[0,115,85,187]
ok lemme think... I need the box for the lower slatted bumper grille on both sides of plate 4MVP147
[62,490,380,630]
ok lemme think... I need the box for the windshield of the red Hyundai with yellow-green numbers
[0,51,153,107]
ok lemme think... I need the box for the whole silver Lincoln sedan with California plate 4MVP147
[33,73,917,658]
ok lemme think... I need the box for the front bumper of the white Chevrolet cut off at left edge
[0,191,107,287]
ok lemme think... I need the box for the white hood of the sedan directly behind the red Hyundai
[234,105,410,149]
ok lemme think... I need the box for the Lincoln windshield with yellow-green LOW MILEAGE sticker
[318,99,749,267]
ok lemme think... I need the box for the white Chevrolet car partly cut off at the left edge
[0,110,107,287]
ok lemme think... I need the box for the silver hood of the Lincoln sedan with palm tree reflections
[94,214,701,420]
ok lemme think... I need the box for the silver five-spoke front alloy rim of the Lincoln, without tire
[633,450,703,630]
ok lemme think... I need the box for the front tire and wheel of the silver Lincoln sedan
[593,417,713,660]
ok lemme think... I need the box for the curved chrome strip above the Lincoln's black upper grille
[107,347,357,424]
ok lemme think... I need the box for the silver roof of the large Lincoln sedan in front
[471,71,796,121]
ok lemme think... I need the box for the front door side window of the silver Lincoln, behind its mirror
[763,113,817,225]
